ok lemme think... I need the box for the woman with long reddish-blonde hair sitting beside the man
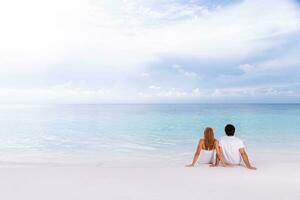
[187,127,226,167]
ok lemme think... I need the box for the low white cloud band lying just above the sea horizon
[0,83,299,103]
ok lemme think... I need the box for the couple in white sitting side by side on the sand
[187,124,256,170]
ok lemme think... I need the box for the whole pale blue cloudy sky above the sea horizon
[0,0,300,103]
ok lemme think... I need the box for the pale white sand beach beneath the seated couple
[0,155,300,200]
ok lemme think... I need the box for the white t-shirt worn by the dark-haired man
[220,136,244,165]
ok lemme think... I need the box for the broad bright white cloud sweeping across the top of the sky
[0,0,300,67]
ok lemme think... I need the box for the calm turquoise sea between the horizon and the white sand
[0,104,300,165]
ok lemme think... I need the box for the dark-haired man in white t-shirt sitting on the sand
[219,124,256,170]
